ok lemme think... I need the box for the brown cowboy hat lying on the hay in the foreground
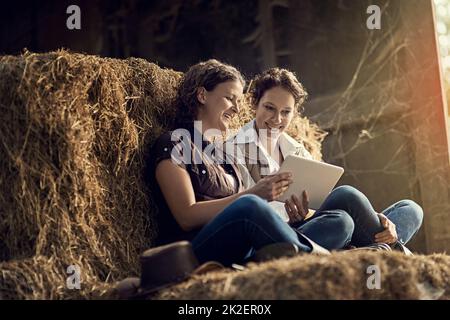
[115,241,225,299]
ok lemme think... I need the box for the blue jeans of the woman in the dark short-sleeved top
[192,195,354,266]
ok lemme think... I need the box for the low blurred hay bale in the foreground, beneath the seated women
[153,251,450,300]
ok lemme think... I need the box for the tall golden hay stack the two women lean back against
[0,50,322,299]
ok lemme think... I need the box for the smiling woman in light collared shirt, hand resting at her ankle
[231,68,423,253]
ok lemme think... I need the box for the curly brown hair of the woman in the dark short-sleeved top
[175,59,245,128]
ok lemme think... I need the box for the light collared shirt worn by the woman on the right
[227,120,313,221]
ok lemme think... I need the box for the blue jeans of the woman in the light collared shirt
[318,186,423,247]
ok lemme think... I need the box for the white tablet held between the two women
[277,155,344,210]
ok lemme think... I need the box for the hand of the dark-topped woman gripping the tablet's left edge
[248,172,292,201]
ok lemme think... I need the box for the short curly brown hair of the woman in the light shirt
[249,68,308,112]
